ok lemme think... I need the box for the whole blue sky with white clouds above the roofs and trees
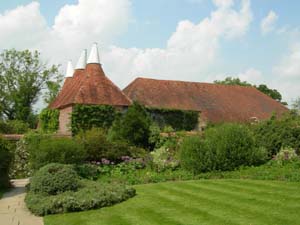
[0,0,300,102]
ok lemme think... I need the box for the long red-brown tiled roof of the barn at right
[123,78,288,122]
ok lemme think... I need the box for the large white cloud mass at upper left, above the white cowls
[0,0,131,63]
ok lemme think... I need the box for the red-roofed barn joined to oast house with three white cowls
[49,44,288,134]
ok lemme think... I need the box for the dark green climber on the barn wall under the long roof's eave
[147,108,198,131]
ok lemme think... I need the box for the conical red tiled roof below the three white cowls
[49,64,131,108]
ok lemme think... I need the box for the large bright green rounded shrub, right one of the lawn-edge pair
[205,123,267,170]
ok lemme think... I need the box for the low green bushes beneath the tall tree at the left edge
[0,120,29,134]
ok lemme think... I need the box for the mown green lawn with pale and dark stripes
[44,180,300,225]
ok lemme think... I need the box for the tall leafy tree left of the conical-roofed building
[0,49,62,127]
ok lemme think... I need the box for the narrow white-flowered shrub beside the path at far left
[10,138,32,179]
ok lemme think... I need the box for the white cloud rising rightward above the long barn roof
[103,0,252,87]
